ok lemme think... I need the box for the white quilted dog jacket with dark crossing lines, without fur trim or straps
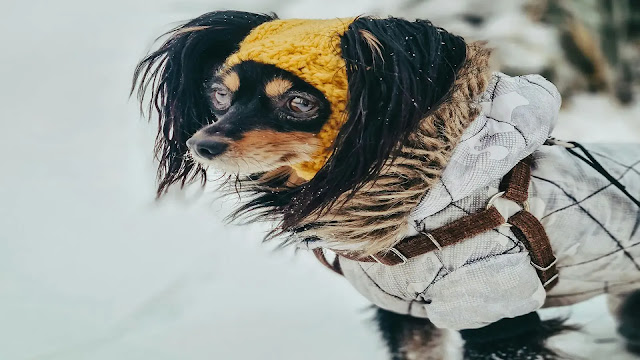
[340,73,640,330]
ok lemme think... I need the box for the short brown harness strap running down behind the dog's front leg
[509,211,558,290]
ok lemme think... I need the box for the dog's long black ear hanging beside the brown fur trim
[283,17,466,225]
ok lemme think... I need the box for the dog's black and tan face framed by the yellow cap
[186,61,331,174]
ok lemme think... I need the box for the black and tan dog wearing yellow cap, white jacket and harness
[132,11,640,360]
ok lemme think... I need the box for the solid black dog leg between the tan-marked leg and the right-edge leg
[461,312,575,360]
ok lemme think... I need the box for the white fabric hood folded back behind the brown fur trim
[409,73,561,235]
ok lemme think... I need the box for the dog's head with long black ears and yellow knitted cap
[134,11,466,222]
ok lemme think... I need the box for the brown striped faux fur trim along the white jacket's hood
[296,42,491,256]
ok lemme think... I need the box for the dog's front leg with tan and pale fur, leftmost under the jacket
[375,309,462,360]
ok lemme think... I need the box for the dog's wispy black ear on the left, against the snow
[131,11,276,196]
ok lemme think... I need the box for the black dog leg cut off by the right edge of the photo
[608,290,640,355]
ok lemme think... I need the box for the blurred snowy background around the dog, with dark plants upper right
[0,0,640,360]
